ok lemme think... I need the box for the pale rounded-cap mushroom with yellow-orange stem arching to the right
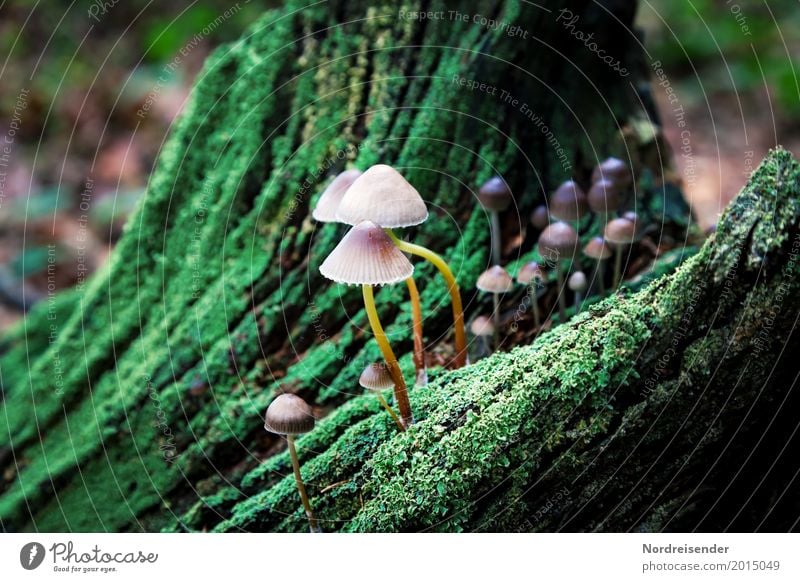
[336,164,467,368]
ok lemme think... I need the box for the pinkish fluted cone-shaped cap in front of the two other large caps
[319,220,414,285]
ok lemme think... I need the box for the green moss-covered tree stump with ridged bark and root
[0,1,797,531]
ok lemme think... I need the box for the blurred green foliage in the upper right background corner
[638,0,800,121]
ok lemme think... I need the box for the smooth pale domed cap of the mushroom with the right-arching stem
[336,164,428,228]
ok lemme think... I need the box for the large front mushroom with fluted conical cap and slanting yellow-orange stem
[319,220,414,426]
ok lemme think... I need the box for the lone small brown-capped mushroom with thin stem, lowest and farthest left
[264,394,322,533]
